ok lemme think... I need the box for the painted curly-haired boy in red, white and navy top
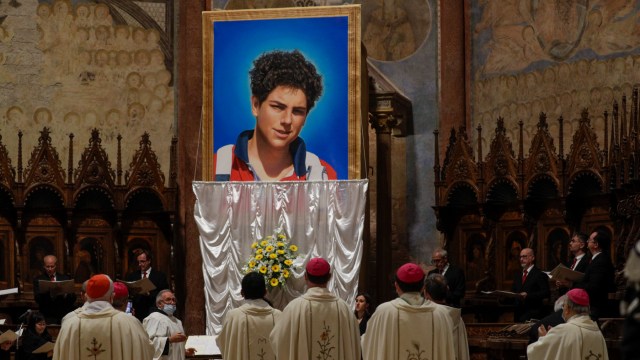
[214,50,337,181]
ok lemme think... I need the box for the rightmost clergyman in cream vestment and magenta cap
[527,289,609,360]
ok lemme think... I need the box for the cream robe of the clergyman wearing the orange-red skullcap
[53,301,153,360]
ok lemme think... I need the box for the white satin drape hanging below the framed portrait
[193,180,368,334]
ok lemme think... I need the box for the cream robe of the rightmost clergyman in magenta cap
[527,315,609,360]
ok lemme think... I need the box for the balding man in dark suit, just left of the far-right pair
[511,248,550,322]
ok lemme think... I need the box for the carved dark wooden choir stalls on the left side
[0,127,177,323]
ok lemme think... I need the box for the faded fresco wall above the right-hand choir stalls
[471,0,640,153]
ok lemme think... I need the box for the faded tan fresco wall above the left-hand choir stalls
[0,0,174,176]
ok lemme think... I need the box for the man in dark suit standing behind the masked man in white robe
[125,250,169,321]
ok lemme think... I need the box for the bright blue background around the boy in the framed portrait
[212,16,349,179]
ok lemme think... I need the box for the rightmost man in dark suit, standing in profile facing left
[574,230,615,320]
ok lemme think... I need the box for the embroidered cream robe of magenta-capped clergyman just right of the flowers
[270,287,360,360]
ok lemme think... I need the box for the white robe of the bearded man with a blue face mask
[142,311,186,360]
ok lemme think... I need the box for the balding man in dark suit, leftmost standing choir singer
[33,255,76,324]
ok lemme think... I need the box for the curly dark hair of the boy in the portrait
[249,50,322,113]
